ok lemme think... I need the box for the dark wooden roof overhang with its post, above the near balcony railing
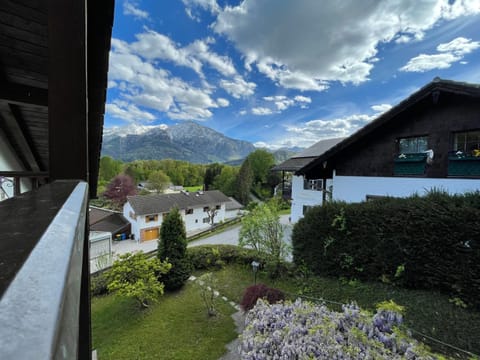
[0,0,114,196]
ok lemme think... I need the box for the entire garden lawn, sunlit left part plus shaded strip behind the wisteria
[92,265,480,360]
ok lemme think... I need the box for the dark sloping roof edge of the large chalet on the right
[296,77,480,179]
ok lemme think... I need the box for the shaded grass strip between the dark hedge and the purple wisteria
[215,265,480,359]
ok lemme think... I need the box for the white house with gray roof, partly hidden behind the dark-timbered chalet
[272,138,344,222]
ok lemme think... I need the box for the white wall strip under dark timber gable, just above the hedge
[333,175,480,202]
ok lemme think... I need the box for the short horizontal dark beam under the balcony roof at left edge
[0,83,48,106]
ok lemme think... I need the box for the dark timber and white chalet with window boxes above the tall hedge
[294,78,480,208]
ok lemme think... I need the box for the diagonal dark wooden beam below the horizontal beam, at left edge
[0,102,40,172]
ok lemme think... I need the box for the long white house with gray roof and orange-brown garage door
[123,190,230,241]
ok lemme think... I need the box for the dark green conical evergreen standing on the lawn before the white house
[157,208,192,290]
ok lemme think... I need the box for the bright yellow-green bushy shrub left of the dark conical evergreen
[107,252,172,308]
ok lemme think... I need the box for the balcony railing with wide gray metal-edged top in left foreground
[0,180,91,359]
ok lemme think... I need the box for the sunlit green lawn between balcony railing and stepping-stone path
[92,283,237,360]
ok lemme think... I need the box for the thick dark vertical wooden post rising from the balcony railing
[48,0,89,181]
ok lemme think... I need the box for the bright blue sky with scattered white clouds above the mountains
[105,0,480,149]
